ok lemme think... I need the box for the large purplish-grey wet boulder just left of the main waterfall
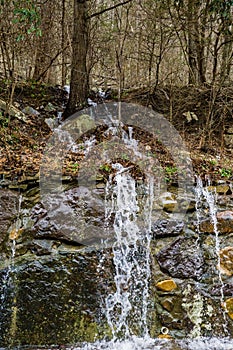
[29,186,110,245]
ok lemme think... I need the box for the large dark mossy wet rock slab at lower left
[0,251,112,348]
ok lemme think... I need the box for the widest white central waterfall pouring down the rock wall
[105,164,153,340]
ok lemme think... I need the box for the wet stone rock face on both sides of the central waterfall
[0,184,233,348]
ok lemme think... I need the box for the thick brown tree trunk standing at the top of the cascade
[63,0,89,119]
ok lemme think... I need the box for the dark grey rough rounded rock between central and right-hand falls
[156,237,204,279]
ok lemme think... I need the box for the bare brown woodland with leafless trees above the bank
[0,0,233,179]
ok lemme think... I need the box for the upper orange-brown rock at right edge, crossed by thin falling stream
[200,210,233,234]
